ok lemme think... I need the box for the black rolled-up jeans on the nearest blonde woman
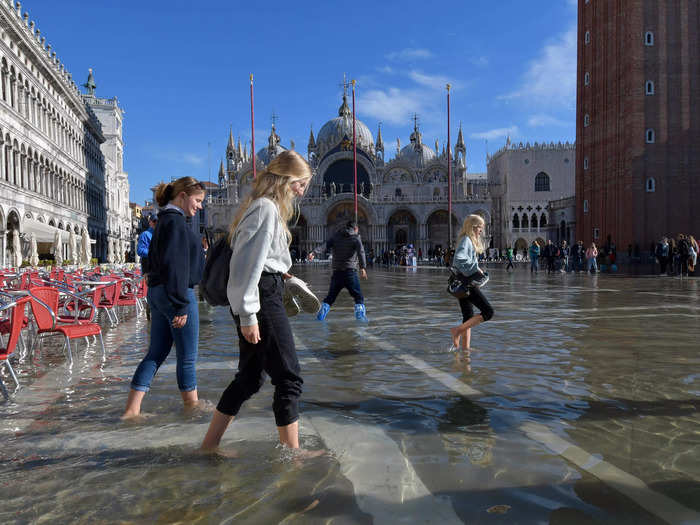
[216,274,304,427]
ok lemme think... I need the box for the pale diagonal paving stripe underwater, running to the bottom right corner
[354,328,700,525]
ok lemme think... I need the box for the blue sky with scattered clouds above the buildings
[22,0,576,204]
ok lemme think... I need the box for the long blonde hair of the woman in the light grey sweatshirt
[228,150,311,244]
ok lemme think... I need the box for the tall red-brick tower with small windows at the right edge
[576,0,700,252]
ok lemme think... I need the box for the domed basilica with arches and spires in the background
[206,90,491,254]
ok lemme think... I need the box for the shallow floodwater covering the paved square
[0,265,700,525]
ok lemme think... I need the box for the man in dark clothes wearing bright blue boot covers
[309,221,367,321]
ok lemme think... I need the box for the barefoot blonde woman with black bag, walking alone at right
[450,215,493,350]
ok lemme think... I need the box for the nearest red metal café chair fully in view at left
[29,286,105,366]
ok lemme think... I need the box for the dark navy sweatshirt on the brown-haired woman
[148,209,204,315]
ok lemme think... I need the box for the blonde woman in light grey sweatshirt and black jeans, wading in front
[202,150,311,451]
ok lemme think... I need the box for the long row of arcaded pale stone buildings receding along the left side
[0,0,128,266]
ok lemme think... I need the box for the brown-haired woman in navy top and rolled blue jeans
[122,177,206,419]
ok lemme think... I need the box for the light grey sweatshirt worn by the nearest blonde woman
[226,197,292,326]
